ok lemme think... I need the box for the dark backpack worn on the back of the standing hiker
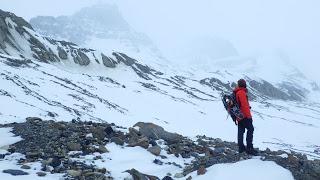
[221,92,244,125]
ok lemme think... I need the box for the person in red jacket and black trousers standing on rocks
[233,79,258,155]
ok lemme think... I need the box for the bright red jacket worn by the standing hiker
[233,87,252,118]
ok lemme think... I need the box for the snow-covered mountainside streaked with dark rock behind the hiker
[0,8,320,180]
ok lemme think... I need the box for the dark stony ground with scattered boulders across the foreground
[1,117,320,180]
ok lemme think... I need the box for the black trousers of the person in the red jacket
[238,118,254,148]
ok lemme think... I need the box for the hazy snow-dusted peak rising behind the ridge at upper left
[30,4,163,63]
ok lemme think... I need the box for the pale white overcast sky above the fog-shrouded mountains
[0,0,320,82]
